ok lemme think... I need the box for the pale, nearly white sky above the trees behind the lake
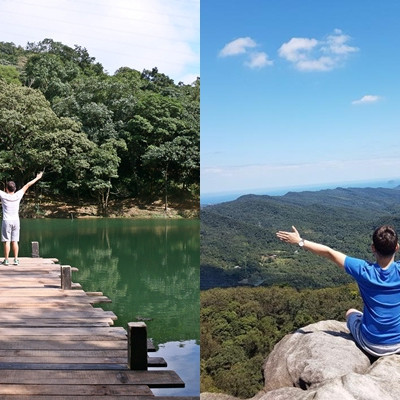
[0,0,200,84]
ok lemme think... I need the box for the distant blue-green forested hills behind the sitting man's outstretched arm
[201,188,400,289]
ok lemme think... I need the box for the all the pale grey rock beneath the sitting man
[201,321,400,400]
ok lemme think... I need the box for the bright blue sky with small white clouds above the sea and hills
[200,0,400,195]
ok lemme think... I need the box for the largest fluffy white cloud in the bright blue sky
[278,29,358,71]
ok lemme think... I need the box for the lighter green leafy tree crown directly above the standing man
[0,80,91,194]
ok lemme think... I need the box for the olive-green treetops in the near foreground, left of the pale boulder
[200,284,361,398]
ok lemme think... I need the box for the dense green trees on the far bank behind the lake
[0,39,200,214]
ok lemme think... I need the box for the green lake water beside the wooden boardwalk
[20,219,200,396]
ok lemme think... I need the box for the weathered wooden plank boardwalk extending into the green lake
[0,258,193,400]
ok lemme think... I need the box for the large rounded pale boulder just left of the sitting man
[264,321,371,390]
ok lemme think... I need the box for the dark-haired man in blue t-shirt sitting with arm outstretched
[276,225,400,357]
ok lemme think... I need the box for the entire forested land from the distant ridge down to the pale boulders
[200,188,400,398]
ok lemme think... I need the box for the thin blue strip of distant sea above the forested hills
[200,178,400,206]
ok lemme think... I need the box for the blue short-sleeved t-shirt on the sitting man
[344,257,400,344]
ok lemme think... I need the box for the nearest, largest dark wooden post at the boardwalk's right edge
[128,322,147,371]
